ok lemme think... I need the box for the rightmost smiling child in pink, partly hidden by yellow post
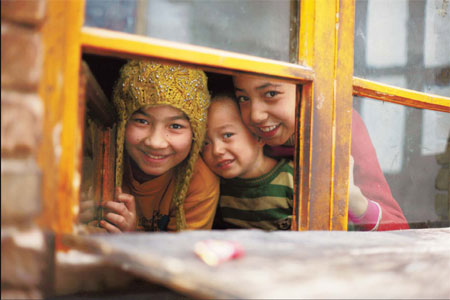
[233,75,409,230]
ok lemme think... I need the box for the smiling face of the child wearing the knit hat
[125,105,192,178]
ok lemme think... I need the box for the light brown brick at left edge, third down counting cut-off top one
[1,90,43,158]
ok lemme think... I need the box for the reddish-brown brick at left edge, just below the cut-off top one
[1,21,43,91]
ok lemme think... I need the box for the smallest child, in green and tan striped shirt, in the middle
[202,94,294,230]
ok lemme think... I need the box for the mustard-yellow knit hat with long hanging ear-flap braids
[113,60,210,230]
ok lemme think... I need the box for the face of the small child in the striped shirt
[202,97,263,178]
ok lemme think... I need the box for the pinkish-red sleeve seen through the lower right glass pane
[351,110,409,231]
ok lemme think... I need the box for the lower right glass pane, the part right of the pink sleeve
[354,96,450,228]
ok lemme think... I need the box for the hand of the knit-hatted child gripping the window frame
[100,187,136,233]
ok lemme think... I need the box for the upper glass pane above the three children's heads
[85,0,298,62]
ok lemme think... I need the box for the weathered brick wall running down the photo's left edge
[1,0,53,299]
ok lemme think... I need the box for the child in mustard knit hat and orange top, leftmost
[100,60,219,232]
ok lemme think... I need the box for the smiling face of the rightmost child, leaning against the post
[233,75,296,146]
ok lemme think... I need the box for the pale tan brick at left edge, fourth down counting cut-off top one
[1,158,41,227]
